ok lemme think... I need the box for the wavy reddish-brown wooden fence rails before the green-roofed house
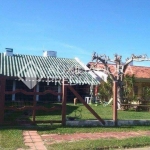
[4,89,62,124]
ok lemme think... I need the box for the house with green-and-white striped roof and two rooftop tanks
[0,48,99,102]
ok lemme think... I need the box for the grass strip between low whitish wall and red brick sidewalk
[37,125,150,134]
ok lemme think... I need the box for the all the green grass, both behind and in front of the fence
[0,103,150,150]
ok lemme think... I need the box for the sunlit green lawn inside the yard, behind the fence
[36,103,150,120]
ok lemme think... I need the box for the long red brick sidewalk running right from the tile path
[42,131,150,145]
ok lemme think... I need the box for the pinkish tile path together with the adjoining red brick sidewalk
[17,131,150,150]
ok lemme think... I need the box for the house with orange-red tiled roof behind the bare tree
[87,62,150,100]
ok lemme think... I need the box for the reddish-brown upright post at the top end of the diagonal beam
[62,79,67,126]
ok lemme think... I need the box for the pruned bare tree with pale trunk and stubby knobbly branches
[90,52,150,109]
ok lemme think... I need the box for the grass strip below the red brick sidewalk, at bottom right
[47,137,150,150]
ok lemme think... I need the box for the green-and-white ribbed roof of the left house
[0,53,99,85]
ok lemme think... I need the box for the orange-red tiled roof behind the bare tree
[88,62,150,79]
